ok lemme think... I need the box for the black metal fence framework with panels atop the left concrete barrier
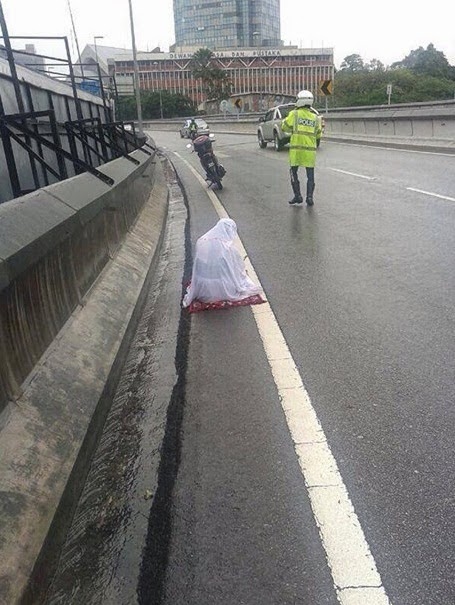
[0,3,154,203]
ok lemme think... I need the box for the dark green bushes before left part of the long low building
[116,90,196,120]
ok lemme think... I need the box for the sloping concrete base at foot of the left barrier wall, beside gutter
[0,155,168,605]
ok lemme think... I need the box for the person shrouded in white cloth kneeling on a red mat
[182,218,261,307]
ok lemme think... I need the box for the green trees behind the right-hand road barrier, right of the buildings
[331,44,455,107]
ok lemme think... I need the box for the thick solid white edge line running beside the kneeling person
[175,153,390,605]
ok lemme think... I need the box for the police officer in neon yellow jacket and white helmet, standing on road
[281,90,322,206]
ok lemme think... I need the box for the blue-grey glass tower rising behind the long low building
[174,0,281,50]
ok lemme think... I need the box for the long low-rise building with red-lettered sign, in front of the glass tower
[113,46,334,105]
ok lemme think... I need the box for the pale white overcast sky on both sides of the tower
[1,0,455,67]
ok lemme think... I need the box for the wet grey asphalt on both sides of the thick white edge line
[156,133,455,605]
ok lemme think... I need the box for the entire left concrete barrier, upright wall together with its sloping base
[0,140,168,605]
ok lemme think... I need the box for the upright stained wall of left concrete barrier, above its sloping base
[0,151,154,410]
